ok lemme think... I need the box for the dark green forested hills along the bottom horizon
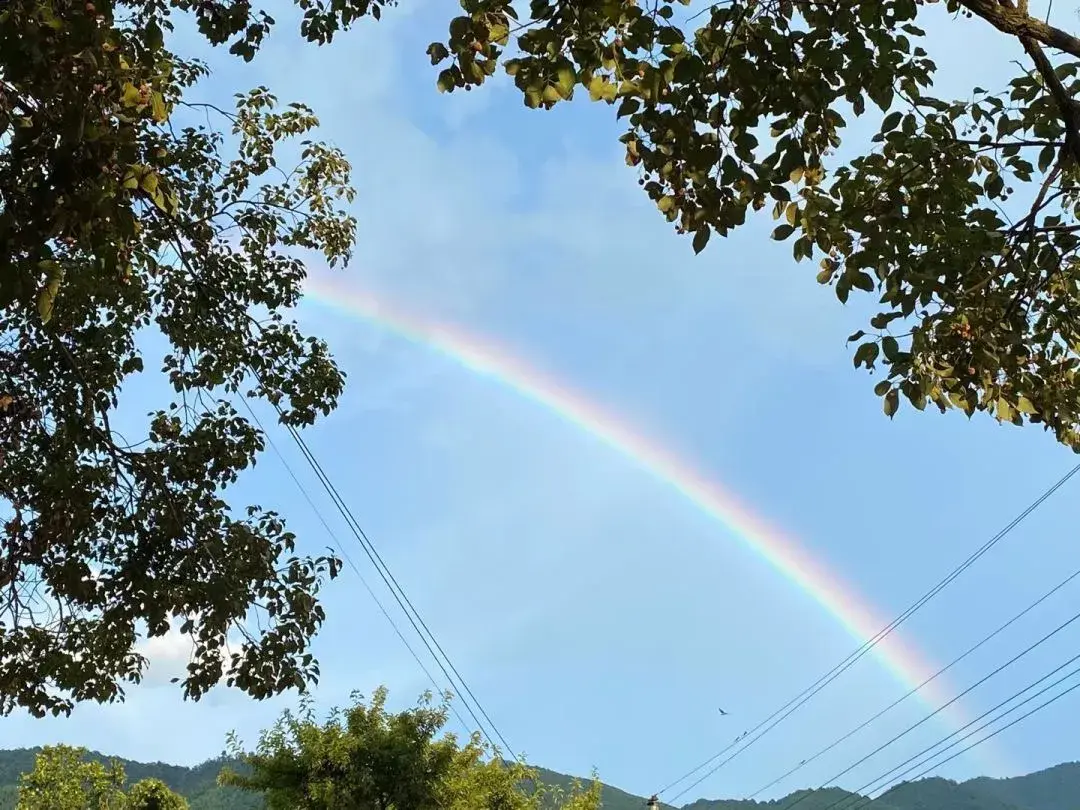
[0,748,1080,810]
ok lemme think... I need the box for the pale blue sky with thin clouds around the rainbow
[0,1,1080,799]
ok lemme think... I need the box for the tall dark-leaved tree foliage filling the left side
[0,0,393,715]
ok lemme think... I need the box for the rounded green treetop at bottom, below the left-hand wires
[221,689,600,810]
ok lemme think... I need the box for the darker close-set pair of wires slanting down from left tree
[249,384,516,759]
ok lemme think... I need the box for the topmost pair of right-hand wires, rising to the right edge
[657,464,1080,804]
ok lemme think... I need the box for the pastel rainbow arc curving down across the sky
[306,276,997,773]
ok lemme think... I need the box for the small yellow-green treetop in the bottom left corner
[17,745,188,810]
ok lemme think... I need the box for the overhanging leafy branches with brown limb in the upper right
[419,0,1080,450]
